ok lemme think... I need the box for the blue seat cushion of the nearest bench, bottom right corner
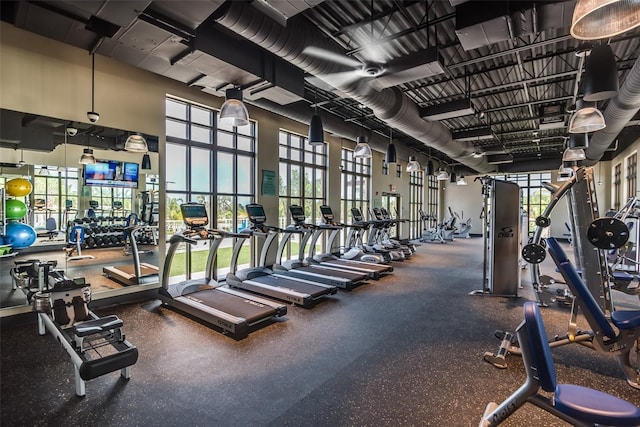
[555,384,640,426]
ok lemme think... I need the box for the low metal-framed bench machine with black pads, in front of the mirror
[33,273,138,396]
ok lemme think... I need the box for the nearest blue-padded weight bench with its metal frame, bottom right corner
[480,301,640,427]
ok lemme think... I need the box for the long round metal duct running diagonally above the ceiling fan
[213,2,494,173]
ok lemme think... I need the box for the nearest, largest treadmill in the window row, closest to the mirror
[158,203,287,338]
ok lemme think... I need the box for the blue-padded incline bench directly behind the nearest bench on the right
[484,238,640,389]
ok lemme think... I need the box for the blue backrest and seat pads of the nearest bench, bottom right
[524,302,640,426]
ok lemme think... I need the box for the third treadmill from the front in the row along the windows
[273,205,369,290]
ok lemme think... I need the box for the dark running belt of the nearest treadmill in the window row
[185,289,276,324]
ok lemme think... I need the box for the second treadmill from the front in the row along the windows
[226,203,338,308]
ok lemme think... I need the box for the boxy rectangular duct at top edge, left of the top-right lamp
[455,0,575,51]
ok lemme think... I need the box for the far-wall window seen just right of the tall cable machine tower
[496,172,551,233]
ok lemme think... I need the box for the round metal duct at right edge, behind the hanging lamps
[583,58,640,166]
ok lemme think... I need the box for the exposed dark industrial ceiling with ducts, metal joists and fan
[0,0,640,173]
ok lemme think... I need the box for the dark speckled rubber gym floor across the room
[0,238,640,427]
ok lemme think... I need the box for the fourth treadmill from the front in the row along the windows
[307,205,393,280]
